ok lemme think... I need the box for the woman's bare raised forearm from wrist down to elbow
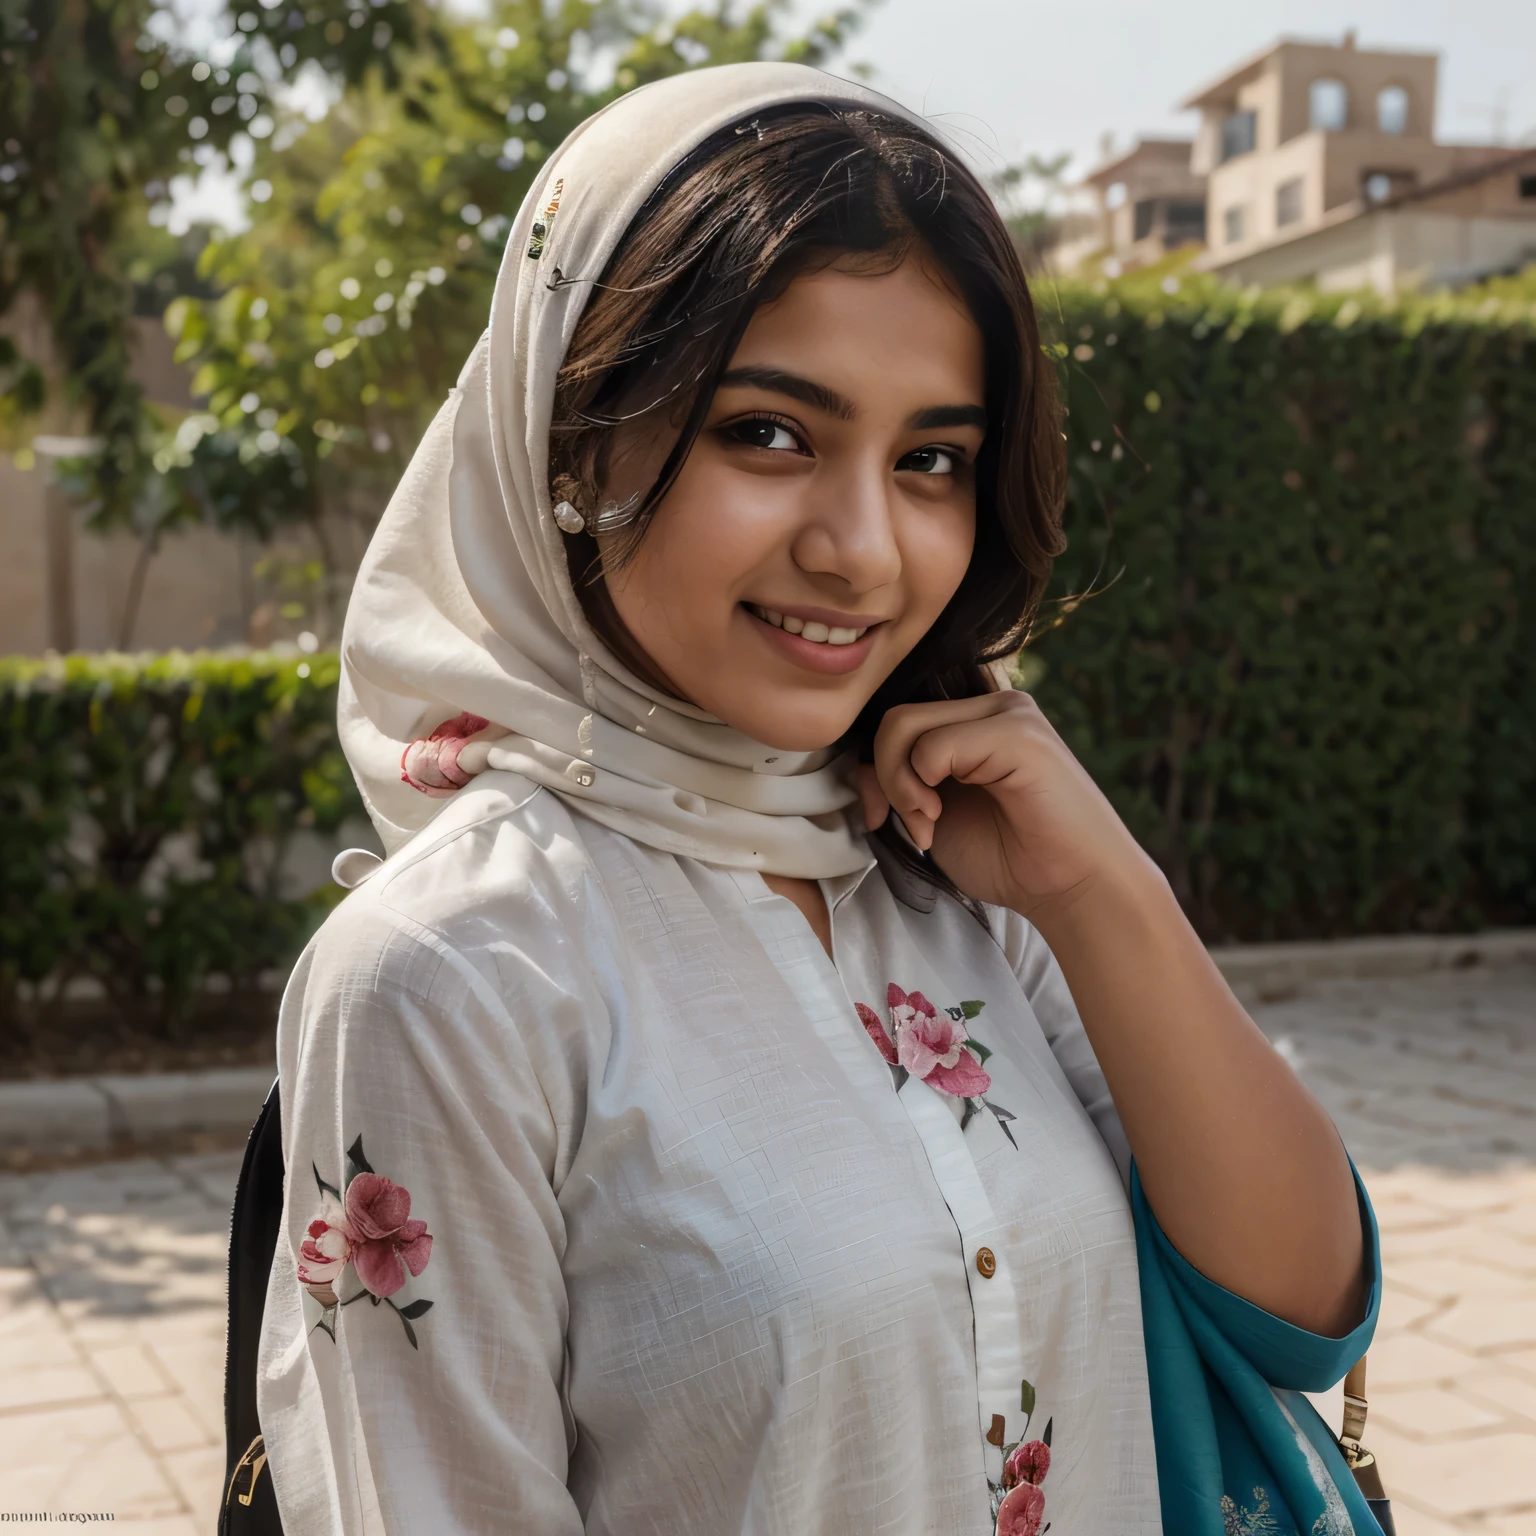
[1031,860,1362,1336]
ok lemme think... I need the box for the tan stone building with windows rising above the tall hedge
[1052,32,1536,292]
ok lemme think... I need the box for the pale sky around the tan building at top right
[829,0,1536,178]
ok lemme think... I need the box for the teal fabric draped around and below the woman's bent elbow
[1130,1166,1381,1536]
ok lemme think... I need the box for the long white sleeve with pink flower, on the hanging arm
[251,892,582,1536]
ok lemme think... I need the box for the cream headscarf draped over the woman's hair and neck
[339,63,933,879]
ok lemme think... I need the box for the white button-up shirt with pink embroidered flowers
[260,773,1161,1536]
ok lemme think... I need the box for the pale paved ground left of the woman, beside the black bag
[0,1152,240,1536]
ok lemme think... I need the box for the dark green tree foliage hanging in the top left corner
[0,0,420,524]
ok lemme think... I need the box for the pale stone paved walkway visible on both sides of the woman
[0,969,1536,1536]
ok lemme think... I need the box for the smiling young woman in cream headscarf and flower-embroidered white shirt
[260,65,1375,1536]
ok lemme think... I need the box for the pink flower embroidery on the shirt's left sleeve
[298,1137,432,1349]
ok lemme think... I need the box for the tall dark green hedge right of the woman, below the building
[1029,275,1536,940]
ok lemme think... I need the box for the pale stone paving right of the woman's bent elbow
[1253,968,1536,1536]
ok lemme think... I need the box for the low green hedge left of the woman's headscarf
[0,653,361,1031]
